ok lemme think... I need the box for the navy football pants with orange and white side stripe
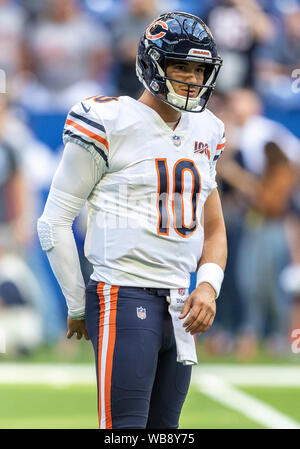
[86,280,191,429]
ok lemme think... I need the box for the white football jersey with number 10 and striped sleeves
[64,96,225,288]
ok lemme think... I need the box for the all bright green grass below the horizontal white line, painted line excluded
[0,376,300,429]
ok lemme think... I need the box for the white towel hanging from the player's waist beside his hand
[167,288,198,365]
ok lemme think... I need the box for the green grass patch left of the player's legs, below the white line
[0,385,98,429]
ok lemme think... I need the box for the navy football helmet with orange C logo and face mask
[136,12,223,112]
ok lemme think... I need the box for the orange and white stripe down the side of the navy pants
[97,282,120,429]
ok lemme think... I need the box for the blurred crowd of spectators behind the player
[0,0,300,360]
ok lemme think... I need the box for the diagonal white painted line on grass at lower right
[192,369,300,429]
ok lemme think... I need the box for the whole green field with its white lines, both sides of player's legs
[0,342,300,429]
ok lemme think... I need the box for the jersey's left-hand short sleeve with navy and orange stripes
[63,100,109,172]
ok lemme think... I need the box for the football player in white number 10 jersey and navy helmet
[38,12,227,428]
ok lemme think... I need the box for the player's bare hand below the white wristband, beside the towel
[179,282,216,335]
